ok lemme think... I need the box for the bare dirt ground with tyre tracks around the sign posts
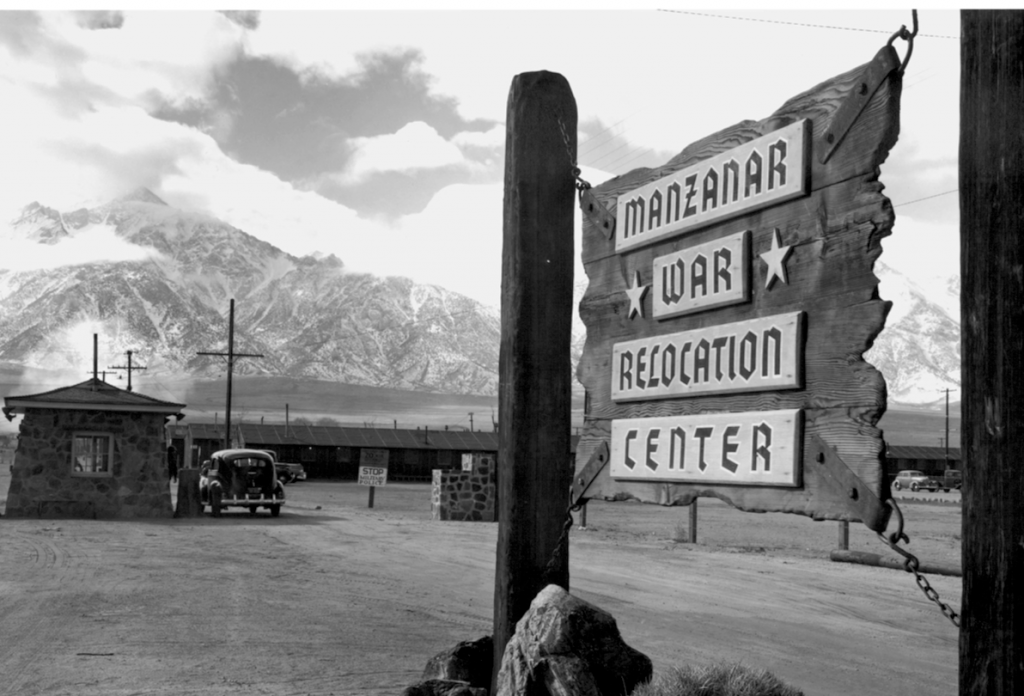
[0,472,961,696]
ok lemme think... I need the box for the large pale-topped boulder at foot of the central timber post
[496,584,651,696]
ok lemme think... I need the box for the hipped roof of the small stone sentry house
[3,378,185,421]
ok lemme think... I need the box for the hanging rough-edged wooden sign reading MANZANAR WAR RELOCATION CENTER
[574,46,902,528]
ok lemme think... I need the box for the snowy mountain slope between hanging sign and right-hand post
[864,261,961,405]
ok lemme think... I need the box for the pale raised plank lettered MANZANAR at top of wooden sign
[615,119,811,253]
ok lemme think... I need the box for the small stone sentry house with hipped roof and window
[3,377,184,519]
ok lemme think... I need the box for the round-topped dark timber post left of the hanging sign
[494,72,577,675]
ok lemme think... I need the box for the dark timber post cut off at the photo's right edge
[959,10,1024,696]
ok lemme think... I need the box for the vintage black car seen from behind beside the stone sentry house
[199,449,285,517]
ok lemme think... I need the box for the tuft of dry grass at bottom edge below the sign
[631,663,804,696]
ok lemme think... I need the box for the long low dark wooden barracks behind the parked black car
[169,423,561,481]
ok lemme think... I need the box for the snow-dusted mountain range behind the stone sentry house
[0,188,500,394]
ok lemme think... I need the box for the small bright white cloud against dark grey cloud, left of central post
[335,121,468,184]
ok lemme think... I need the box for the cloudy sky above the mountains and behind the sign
[0,8,959,306]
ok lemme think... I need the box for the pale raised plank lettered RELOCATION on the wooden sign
[611,312,804,401]
